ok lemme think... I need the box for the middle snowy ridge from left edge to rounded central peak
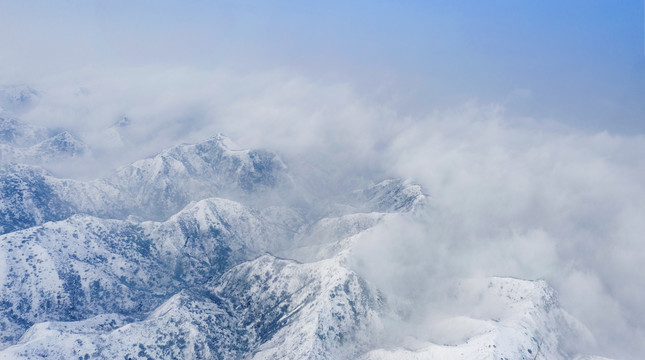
[0,195,302,343]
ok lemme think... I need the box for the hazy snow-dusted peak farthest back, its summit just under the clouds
[99,135,291,219]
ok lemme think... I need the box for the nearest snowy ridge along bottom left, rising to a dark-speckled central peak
[0,255,384,359]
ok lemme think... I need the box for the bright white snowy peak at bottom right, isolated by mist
[361,277,593,360]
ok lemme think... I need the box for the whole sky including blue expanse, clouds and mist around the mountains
[0,0,645,359]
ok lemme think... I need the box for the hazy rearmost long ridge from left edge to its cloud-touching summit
[0,135,299,232]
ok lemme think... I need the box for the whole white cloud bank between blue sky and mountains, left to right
[5,68,645,359]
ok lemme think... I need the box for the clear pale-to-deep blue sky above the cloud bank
[0,0,645,134]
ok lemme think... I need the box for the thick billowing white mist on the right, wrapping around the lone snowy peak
[350,104,645,359]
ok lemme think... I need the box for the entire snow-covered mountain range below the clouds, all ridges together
[0,132,608,359]
